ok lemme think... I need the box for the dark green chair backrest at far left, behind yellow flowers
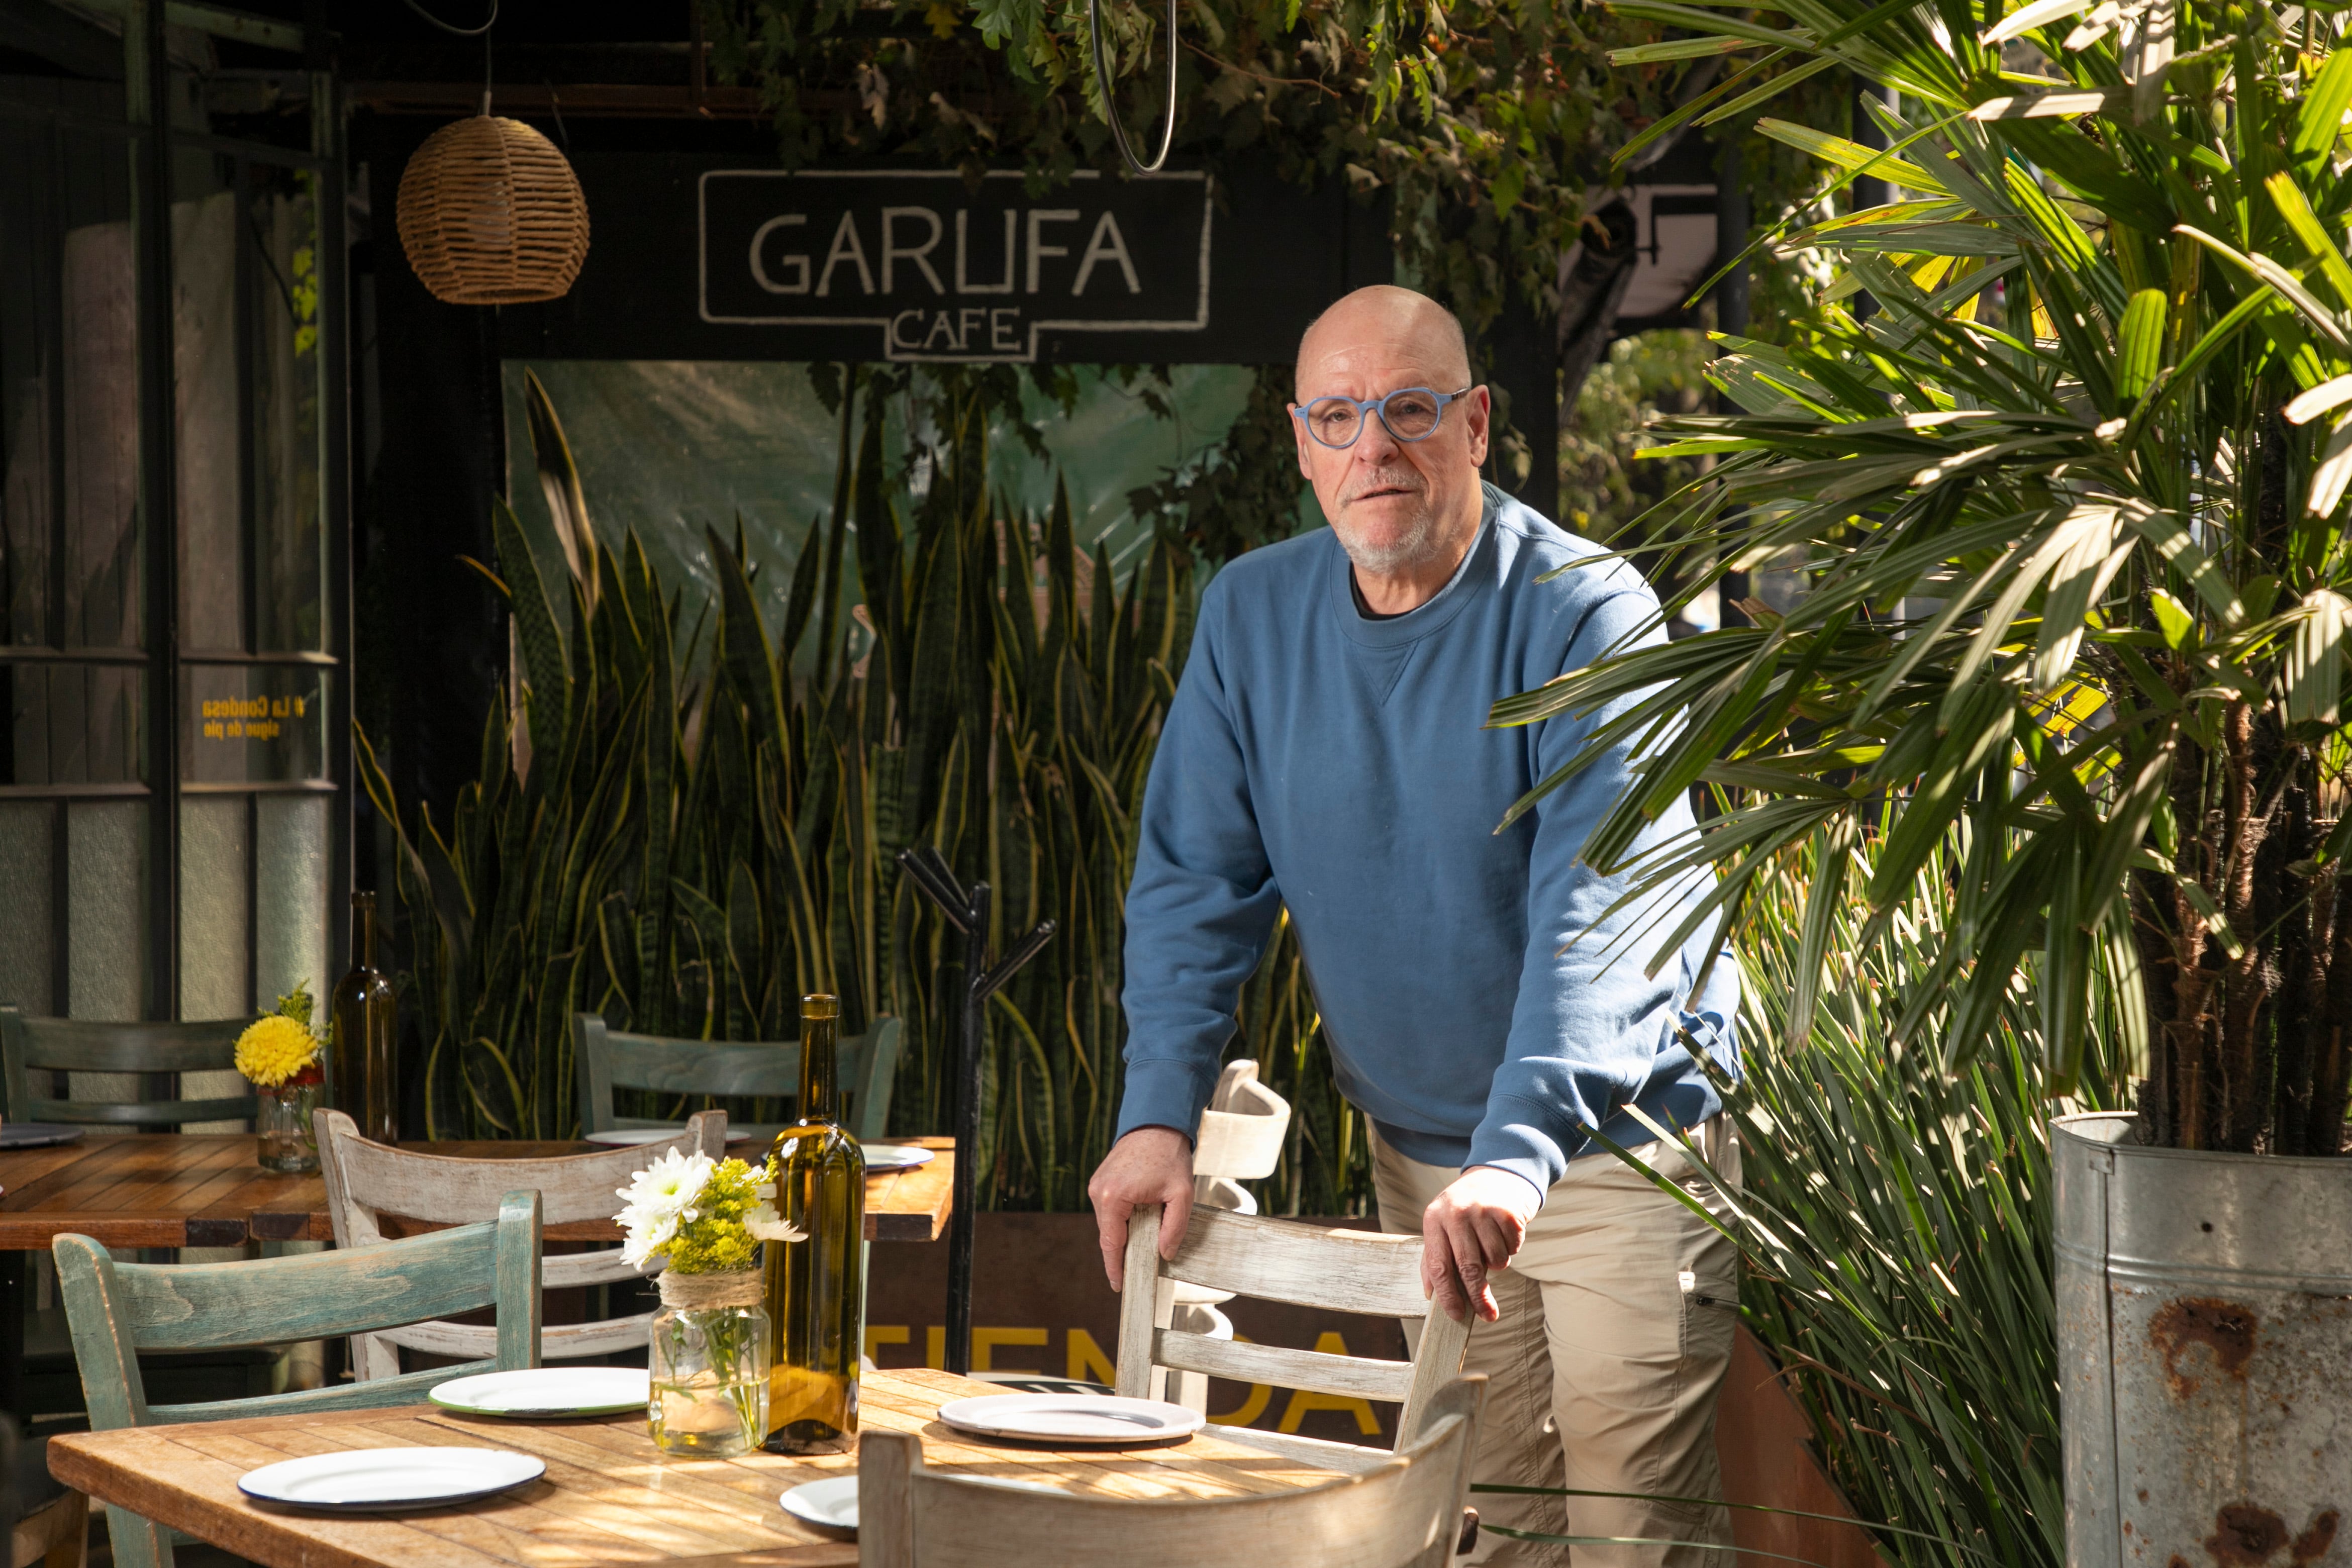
[0,1006,254,1128]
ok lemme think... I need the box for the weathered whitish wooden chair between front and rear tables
[315,1110,727,1382]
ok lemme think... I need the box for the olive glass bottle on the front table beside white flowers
[767,997,865,1453]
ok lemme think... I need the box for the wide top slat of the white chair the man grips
[1164,1211,1430,1316]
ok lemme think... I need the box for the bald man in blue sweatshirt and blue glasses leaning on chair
[1089,287,1738,1565]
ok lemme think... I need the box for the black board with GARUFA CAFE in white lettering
[499,150,1395,364]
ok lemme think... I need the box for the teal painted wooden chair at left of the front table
[49,1192,541,1568]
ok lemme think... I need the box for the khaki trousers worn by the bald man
[1371,1117,1740,1568]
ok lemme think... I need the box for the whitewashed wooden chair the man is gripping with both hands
[1117,1204,1470,1469]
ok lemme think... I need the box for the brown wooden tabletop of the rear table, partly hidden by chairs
[0,1133,955,1251]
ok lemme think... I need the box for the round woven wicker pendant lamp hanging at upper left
[400,113,588,306]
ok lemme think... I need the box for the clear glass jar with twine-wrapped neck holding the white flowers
[644,1269,767,1460]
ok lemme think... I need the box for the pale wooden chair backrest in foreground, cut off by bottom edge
[858,1378,1487,1568]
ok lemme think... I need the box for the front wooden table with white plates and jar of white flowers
[49,1370,1334,1568]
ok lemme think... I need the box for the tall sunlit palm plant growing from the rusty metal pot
[1494,0,2352,1154]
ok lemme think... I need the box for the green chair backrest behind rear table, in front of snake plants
[571,1013,899,1142]
